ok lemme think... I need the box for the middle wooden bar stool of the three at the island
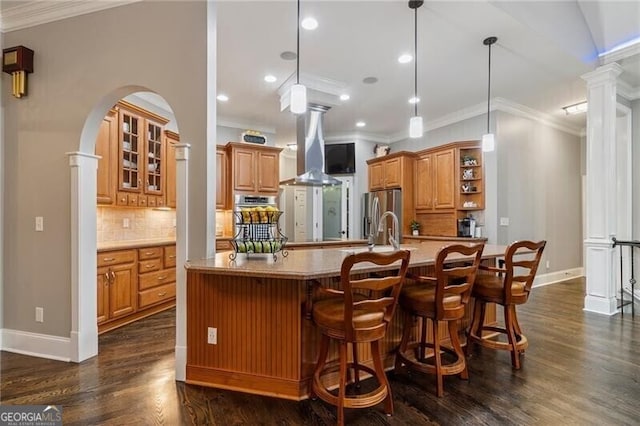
[396,244,484,396]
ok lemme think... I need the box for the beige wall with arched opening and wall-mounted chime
[2,1,207,337]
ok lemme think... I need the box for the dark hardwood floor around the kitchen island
[0,279,640,425]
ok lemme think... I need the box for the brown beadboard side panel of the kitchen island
[187,271,306,400]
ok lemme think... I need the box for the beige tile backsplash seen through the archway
[97,206,176,243]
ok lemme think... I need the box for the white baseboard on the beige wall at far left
[0,328,71,362]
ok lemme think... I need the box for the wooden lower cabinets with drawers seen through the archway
[97,245,176,333]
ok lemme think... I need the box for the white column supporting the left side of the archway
[67,152,100,362]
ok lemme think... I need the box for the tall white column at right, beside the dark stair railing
[582,63,622,315]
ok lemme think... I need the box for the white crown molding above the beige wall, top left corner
[0,0,142,33]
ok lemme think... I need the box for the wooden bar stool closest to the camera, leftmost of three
[311,250,410,425]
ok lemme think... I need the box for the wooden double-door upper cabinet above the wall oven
[227,142,282,195]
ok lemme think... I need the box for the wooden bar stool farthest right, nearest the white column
[466,241,547,370]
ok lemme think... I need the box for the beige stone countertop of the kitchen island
[185,241,505,280]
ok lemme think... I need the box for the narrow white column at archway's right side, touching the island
[175,143,191,382]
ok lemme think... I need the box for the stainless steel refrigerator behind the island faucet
[362,189,402,244]
